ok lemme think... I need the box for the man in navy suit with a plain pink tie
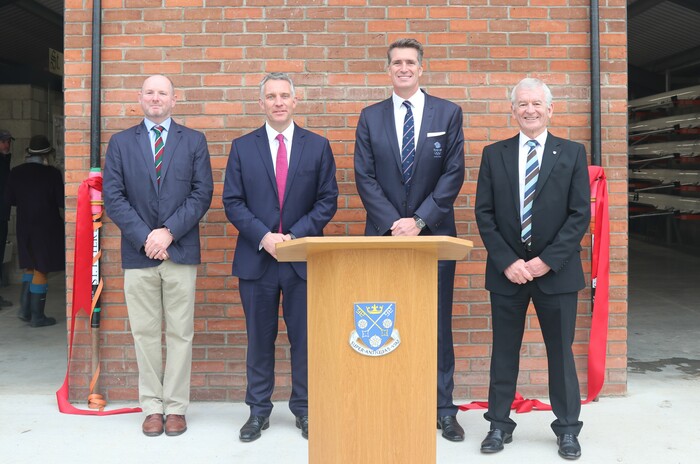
[223,73,338,442]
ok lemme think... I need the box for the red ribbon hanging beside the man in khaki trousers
[56,175,141,416]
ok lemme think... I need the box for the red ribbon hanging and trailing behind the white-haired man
[459,166,610,414]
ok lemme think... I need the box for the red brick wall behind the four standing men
[65,0,627,401]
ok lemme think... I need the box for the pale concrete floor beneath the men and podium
[0,242,700,464]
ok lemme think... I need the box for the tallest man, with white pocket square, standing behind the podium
[355,39,464,441]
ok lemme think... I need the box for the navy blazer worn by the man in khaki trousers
[103,121,214,269]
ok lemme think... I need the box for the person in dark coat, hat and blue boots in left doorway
[5,135,66,327]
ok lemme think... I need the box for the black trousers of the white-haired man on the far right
[484,281,583,435]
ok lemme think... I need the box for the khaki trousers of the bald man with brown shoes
[124,260,197,415]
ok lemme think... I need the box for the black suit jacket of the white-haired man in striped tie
[475,133,591,295]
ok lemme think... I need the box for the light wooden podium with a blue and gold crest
[277,236,472,464]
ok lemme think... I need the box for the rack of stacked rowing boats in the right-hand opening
[628,86,700,249]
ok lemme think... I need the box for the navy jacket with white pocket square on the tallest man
[355,90,464,236]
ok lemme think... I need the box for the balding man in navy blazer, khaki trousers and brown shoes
[103,75,214,436]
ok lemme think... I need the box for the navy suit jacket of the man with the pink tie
[223,125,338,280]
